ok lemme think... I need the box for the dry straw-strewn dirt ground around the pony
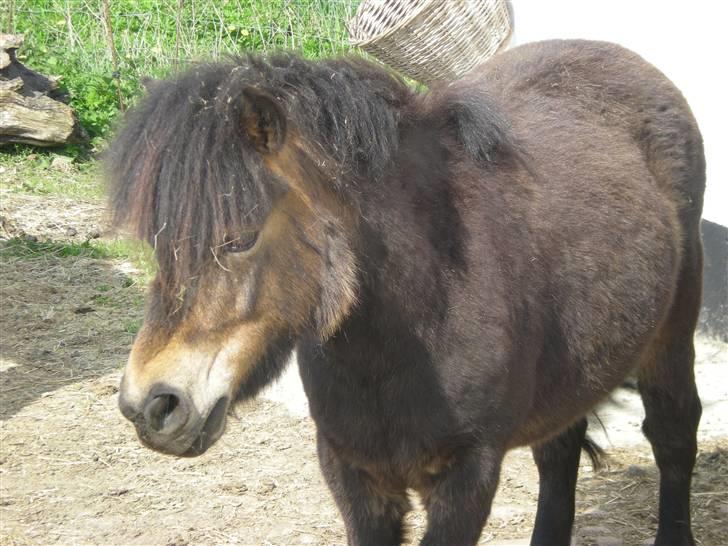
[0,185,728,546]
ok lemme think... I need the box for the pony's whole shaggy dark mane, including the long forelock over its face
[107,54,411,306]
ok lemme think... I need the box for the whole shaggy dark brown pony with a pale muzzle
[109,41,705,546]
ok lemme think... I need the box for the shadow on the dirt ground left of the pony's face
[0,240,143,420]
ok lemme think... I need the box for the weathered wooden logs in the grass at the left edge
[0,34,88,147]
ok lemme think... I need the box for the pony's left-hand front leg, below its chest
[317,433,410,546]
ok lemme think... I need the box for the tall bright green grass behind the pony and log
[0,0,359,143]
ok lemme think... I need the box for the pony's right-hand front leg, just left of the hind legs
[420,447,504,546]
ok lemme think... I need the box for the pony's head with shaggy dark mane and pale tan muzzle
[108,55,408,455]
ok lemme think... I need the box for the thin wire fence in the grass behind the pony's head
[3,0,358,64]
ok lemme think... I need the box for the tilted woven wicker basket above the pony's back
[349,0,511,84]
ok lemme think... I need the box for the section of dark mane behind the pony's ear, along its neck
[258,54,413,179]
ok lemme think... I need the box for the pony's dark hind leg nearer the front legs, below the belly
[531,419,587,546]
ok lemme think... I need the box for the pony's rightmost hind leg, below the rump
[638,235,702,546]
